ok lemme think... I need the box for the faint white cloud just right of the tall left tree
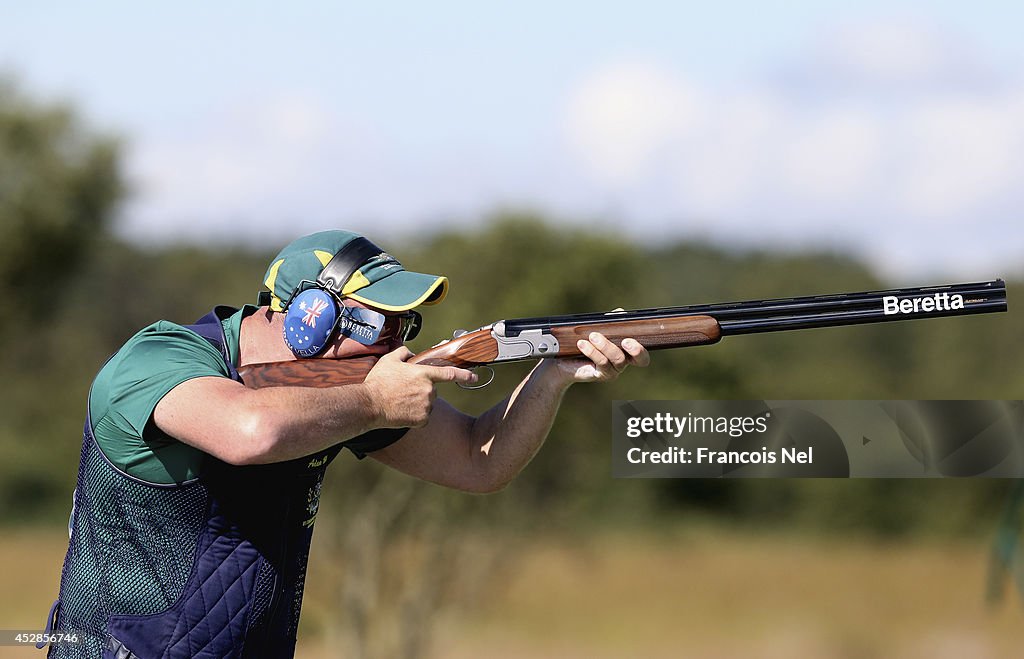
[128,94,361,236]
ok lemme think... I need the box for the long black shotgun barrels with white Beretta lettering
[505,279,1007,337]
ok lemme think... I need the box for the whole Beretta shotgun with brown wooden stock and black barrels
[239,279,1007,389]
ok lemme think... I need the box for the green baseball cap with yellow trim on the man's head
[260,230,449,311]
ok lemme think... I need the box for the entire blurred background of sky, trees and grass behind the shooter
[0,0,1024,658]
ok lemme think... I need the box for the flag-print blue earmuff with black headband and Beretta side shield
[284,237,420,357]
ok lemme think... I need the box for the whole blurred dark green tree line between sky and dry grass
[0,75,1024,656]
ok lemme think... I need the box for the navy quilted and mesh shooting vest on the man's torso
[48,307,406,659]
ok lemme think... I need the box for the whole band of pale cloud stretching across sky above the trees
[110,15,1024,272]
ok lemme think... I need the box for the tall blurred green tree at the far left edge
[0,80,123,520]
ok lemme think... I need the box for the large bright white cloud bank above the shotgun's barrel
[566,21,1024,272]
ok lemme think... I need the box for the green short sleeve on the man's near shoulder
[89,320,228,484]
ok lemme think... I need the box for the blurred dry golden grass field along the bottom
[0,530,1024,659]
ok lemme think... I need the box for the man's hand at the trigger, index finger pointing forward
[362,347,477,428]
